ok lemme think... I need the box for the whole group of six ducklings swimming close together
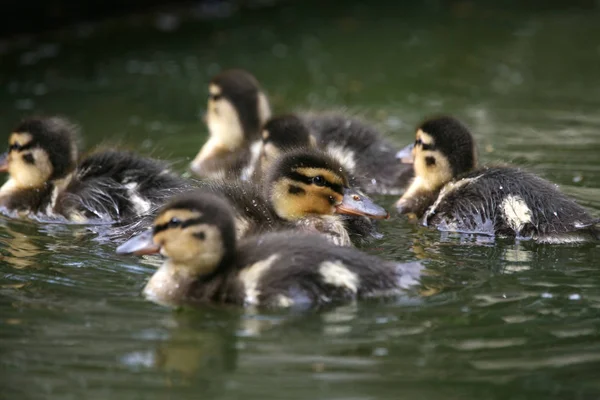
[0,70,600,308]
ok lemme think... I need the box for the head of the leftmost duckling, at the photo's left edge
[0,117,78,189]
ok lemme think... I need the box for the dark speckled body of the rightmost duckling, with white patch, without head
[423,167,600,243]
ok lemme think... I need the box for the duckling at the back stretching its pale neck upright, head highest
[190,69,271,178]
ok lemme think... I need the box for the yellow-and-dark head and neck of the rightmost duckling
[396,116,477,212]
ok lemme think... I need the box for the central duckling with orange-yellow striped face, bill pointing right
[196,149,389,246]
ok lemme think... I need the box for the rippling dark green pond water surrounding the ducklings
[0,1,600,399]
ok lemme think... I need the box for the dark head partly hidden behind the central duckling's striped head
[258,114,317,174]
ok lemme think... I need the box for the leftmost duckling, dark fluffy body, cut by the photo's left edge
[0,117,189,223]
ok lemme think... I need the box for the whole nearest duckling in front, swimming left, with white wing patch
[117,192,422,309]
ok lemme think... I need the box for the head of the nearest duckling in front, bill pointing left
[117,191,236,276]
